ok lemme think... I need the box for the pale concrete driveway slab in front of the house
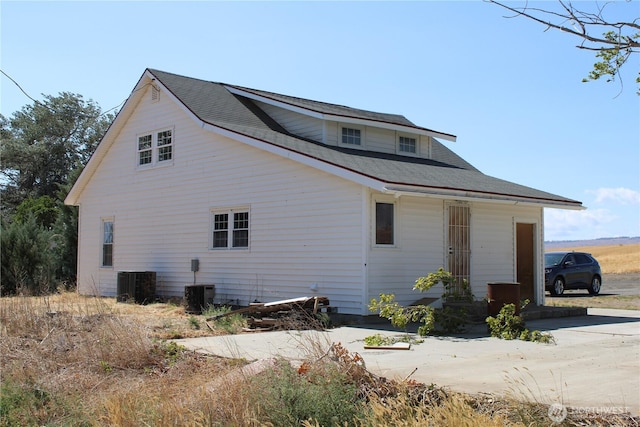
[176,309,640,415]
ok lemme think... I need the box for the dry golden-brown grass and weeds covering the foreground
[0,293,638,427]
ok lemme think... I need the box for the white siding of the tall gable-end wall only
[78,87,365,314]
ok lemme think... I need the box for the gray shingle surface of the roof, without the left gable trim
[149,70,581,207]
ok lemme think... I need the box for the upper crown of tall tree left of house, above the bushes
[0,92,113,214]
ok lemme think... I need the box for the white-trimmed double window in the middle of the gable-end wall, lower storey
[211,209,249,249]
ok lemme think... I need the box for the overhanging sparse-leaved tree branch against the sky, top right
[487,0,640,94]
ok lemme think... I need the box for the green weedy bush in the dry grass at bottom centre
[251,360,365,426]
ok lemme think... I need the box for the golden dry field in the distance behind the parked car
[548,244,640,274]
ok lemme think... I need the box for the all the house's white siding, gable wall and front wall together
[78,84,543,314]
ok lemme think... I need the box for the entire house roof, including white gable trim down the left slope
[67,69,582,209]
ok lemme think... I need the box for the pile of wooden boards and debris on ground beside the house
[207,297,331,332]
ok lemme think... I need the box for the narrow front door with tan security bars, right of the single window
[447,205,471,290]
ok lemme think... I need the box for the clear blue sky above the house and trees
[0,0,640,240]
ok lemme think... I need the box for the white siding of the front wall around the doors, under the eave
[367,195,544,310]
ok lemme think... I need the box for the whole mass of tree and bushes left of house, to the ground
[0,92,114,294]
